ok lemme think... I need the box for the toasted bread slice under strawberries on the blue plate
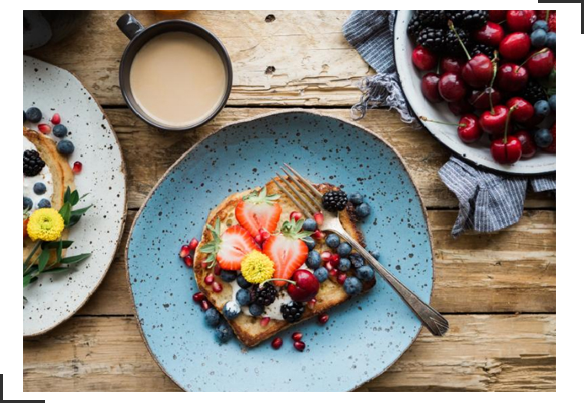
[193,178,375,347]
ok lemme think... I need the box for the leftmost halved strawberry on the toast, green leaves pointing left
[201,219,260,270]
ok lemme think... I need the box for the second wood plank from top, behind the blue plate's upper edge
[106,108,555,208]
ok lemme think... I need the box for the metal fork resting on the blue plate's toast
[273,164,448,336]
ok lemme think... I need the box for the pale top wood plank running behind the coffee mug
[31,11,374,106]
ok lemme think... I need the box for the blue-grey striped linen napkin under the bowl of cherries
[343,10,556,237]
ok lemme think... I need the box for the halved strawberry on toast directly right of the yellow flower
[263,220,311,286]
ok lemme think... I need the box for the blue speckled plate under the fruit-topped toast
[127,111,433,391]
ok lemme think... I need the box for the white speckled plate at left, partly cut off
[23,56,126,337]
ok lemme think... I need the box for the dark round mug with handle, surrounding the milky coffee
[117,13,233,131]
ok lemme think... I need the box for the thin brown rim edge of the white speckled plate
[22,54,128,340]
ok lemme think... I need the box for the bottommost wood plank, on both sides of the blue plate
[23,315,556,392]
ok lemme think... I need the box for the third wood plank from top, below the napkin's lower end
[81,211,556,315]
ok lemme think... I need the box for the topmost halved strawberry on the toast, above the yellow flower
[235,187,282,237]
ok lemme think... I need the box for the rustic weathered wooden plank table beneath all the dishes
[23,11,556,391]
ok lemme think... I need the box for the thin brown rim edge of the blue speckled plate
[124,108,436,392]
